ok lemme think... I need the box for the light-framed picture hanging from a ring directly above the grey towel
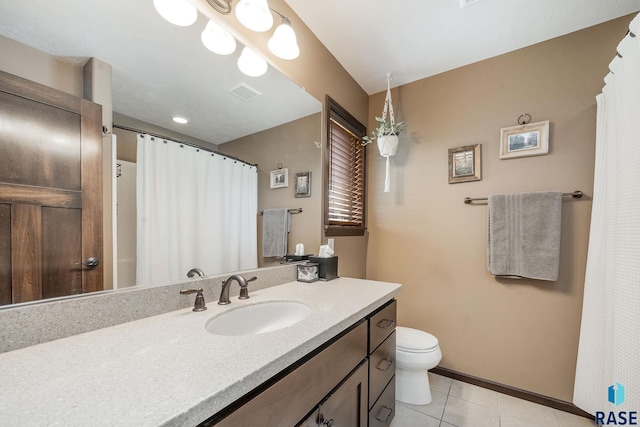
[500,120,549,159]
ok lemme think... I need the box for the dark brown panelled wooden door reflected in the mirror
[0,72,103,305]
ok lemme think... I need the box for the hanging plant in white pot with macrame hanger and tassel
[362,74,406,193]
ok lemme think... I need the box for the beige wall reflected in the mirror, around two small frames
[218,113,322,267]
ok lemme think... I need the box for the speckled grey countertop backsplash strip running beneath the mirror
[0,265,297,353]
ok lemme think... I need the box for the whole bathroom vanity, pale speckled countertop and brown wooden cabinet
[0,278,400,427]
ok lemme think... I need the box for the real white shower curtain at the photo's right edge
[573,15,640,415]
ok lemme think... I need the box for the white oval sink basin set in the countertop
[205,301,311,335]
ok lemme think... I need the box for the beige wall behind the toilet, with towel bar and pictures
[367,16,631,401]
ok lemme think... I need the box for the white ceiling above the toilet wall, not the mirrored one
[285,0,640,95]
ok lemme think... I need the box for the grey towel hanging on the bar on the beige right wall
[487,192,562,281]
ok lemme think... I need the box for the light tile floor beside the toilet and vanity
[391,373,595,427]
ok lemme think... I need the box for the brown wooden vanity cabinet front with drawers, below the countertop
[200,300,396,427]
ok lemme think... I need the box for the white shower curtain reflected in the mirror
[136,135,258,285]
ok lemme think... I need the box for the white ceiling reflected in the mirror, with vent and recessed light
[0,0,321,144]
